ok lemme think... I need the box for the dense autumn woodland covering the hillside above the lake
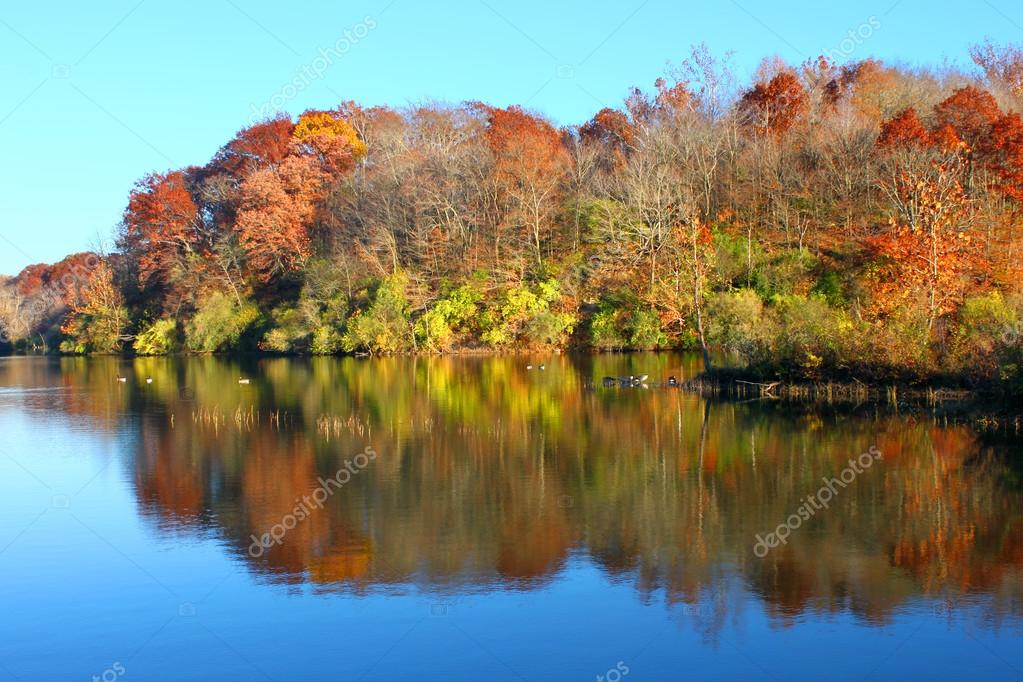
[0,43,1023,393]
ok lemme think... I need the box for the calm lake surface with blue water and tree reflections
[0,355,1023,682]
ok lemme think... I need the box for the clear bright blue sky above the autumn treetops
[0,0,1023,274]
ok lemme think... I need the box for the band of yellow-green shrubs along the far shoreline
[7,254,1023,396]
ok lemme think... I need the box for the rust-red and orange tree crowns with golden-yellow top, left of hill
[120,111,366,290]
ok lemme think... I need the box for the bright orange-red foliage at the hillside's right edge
[873,86,1023,329]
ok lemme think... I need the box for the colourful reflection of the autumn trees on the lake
[0,355,1023,628]
